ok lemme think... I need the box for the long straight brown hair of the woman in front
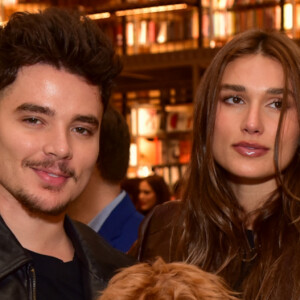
[179,30,300,300]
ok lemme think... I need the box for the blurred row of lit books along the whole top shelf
[101,0,300,54]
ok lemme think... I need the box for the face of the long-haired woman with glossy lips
[213,54,299,182]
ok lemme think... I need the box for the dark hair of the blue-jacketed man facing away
[97,106,130,183]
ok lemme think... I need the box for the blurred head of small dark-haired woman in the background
[137,175,171,215]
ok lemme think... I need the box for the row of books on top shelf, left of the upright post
[100,9,199,53]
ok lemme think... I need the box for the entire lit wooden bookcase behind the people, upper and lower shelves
[87,0,300,185]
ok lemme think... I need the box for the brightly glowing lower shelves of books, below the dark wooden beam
[128,103,193,185]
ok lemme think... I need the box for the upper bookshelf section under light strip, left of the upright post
[91,0,201,55]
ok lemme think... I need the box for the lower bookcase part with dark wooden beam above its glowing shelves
[112,48,218,185]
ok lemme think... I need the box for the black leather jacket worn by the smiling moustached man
[0,217,134,300]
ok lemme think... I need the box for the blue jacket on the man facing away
[98,193,144,252]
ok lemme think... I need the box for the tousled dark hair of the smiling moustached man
[0,8,121,107]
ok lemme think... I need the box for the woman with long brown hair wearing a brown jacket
[132,30,300,300]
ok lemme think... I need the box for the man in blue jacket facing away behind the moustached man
[68,107,143,252]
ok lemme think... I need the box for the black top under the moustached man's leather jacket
[29,251,84,300]
